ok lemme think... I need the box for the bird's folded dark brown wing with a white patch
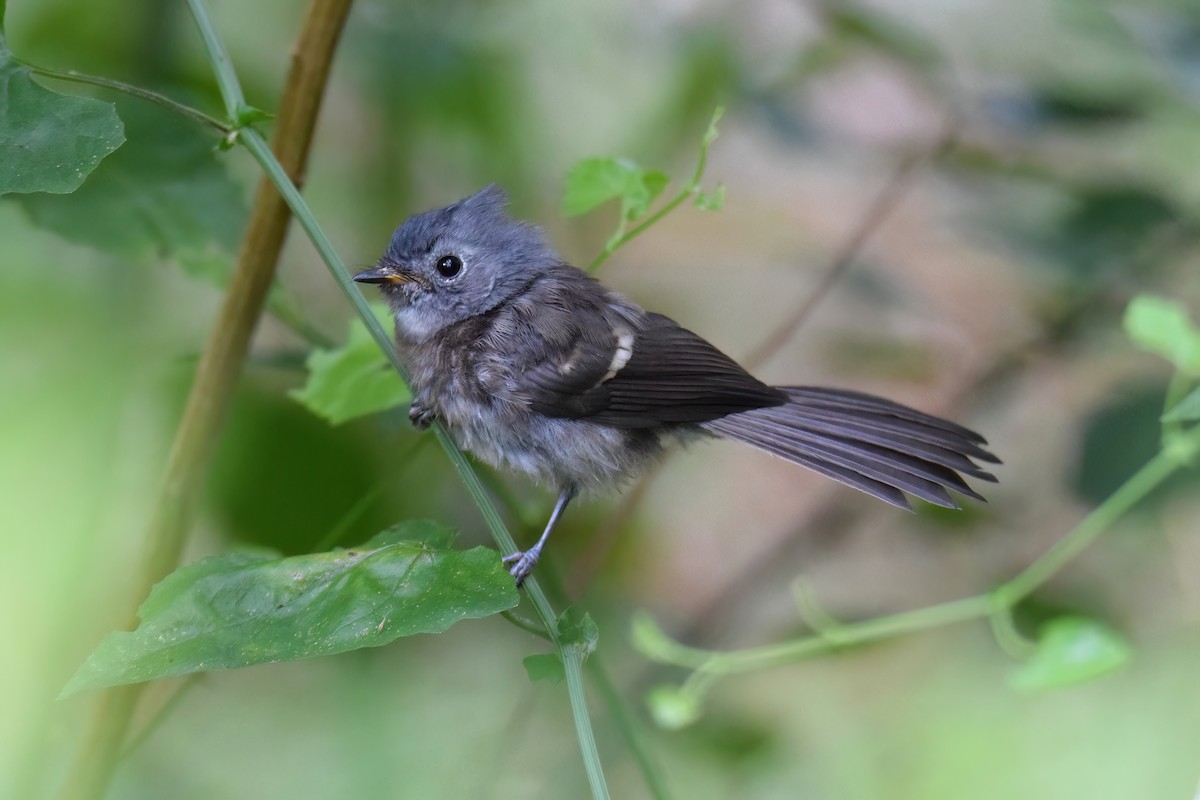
[514,311,787,428]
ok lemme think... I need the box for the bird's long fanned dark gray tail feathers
[702,386,1000,509]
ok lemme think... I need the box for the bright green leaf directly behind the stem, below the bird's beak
[289,306,412,425]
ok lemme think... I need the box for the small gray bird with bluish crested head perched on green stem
[354,186,998,585]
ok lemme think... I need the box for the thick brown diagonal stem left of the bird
[59,0,350,800]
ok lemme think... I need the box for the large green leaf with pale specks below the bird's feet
[62,523,517,696]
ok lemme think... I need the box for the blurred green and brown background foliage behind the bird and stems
[0,0,1200,800]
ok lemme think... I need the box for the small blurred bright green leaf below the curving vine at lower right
[1009,616,1133,692]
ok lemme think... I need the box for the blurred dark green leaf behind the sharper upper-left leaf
[16,98,246,285]
